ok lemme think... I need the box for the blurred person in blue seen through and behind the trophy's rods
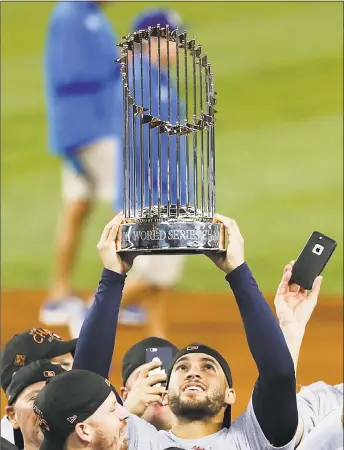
[117,8,192,337]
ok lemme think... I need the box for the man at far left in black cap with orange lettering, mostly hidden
[1,328,77,447]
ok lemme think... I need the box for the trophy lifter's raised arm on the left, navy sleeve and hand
[73,214,134,378]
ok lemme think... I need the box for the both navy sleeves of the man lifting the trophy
[73,263,298,447]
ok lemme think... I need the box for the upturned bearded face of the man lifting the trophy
[168,353,234,421]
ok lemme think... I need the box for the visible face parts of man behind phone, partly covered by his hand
[121,366,173,430]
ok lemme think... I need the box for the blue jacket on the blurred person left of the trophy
[44,2,122,170]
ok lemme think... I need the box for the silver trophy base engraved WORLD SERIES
[118,220,226,255]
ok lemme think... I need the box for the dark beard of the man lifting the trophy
[168,390,225,422]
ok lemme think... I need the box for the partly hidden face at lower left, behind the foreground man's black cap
[6,381,45,448]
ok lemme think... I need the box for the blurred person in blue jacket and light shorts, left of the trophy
[40,1,122,337]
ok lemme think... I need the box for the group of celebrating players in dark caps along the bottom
[1,214,343,450]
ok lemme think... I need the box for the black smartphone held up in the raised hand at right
[289,231,337,290]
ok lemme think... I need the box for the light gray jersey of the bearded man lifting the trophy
[127,401,295,450]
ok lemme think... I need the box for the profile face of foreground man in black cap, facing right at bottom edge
[85,392,128,450]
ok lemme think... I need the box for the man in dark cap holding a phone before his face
[121,337,178,430]
